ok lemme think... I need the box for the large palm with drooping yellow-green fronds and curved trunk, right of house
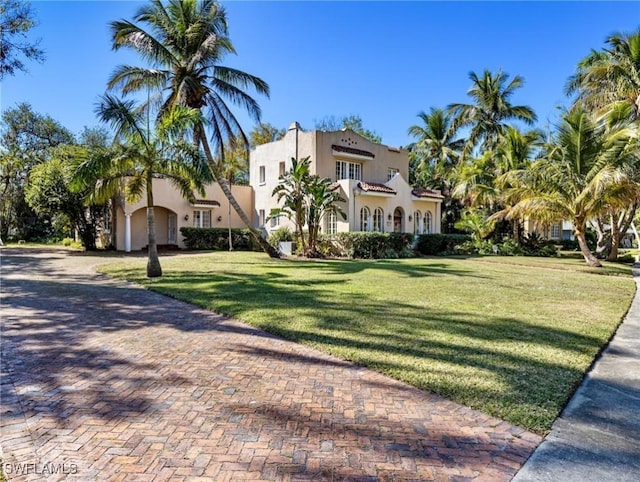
[494,109,640,266]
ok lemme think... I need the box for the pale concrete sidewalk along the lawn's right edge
[513,265,640,482]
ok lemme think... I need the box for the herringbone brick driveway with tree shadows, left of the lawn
[0,249,540,481]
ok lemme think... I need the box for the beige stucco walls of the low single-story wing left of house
[114,179,253,251]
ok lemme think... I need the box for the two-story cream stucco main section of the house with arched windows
[249,122,443,234]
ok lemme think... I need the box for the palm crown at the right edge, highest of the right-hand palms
[565,30,640,119]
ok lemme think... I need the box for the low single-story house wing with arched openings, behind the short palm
[107,178,253,252]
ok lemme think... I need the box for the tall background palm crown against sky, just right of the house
[447,70,537,156]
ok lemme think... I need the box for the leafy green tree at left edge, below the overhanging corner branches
[0,103,75,240]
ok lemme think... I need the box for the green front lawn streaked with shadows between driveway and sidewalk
[101,252,635,434]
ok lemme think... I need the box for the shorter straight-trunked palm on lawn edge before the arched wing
[75,95,212,278]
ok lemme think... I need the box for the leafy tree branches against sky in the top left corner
[0,0,44,80]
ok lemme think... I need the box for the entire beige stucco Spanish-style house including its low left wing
[101,122,443,252]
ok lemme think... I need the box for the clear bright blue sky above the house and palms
[0,1,640,146]
